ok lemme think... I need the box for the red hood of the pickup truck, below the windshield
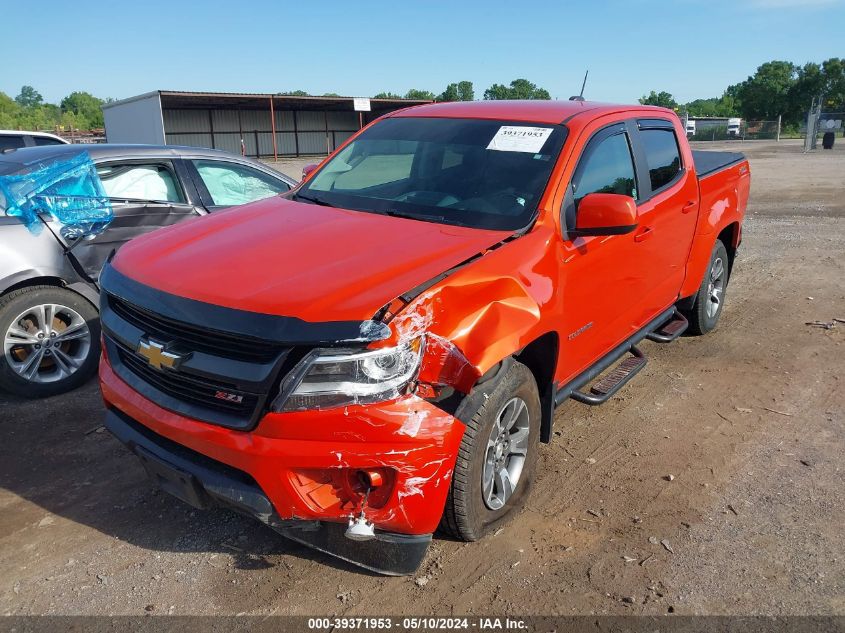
[112,197,509,322]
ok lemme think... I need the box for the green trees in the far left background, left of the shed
[0,86,111,131]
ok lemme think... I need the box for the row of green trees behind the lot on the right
[639,57,845,126]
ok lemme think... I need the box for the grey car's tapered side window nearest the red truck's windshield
[186,158,291,211]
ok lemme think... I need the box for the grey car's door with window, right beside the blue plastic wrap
[70,158,204,279]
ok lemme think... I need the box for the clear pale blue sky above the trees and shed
[0,0,845,102]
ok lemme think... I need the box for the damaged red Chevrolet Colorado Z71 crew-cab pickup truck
[95,101,750,574]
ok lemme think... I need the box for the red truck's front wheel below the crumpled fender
[440,361,541,541]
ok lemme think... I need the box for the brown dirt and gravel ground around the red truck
[0,139,845,615]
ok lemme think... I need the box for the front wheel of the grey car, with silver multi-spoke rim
[0,286,100,398]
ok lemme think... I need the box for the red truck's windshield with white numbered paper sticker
[295,117,566,231]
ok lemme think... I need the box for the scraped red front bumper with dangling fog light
[100,358,464,574]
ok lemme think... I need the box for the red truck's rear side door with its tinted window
[628,119,699,325]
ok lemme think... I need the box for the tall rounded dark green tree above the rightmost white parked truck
[737,61,798,120]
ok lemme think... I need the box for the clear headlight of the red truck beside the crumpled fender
[273,338,423,411]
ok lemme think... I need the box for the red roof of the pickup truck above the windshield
[388,100,674,124]
